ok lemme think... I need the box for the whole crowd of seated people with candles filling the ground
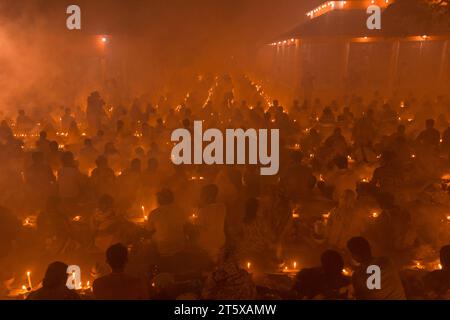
[0,75,450,300]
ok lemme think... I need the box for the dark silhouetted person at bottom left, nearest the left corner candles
[27,262,80,300]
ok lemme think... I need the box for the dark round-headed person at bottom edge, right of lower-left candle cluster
[93,243,148,300]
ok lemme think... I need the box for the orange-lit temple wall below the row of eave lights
[255,37,450,105]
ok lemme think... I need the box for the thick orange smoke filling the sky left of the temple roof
[0,0,307,114]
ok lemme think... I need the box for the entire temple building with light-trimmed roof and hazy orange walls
[258,0,450,101]
